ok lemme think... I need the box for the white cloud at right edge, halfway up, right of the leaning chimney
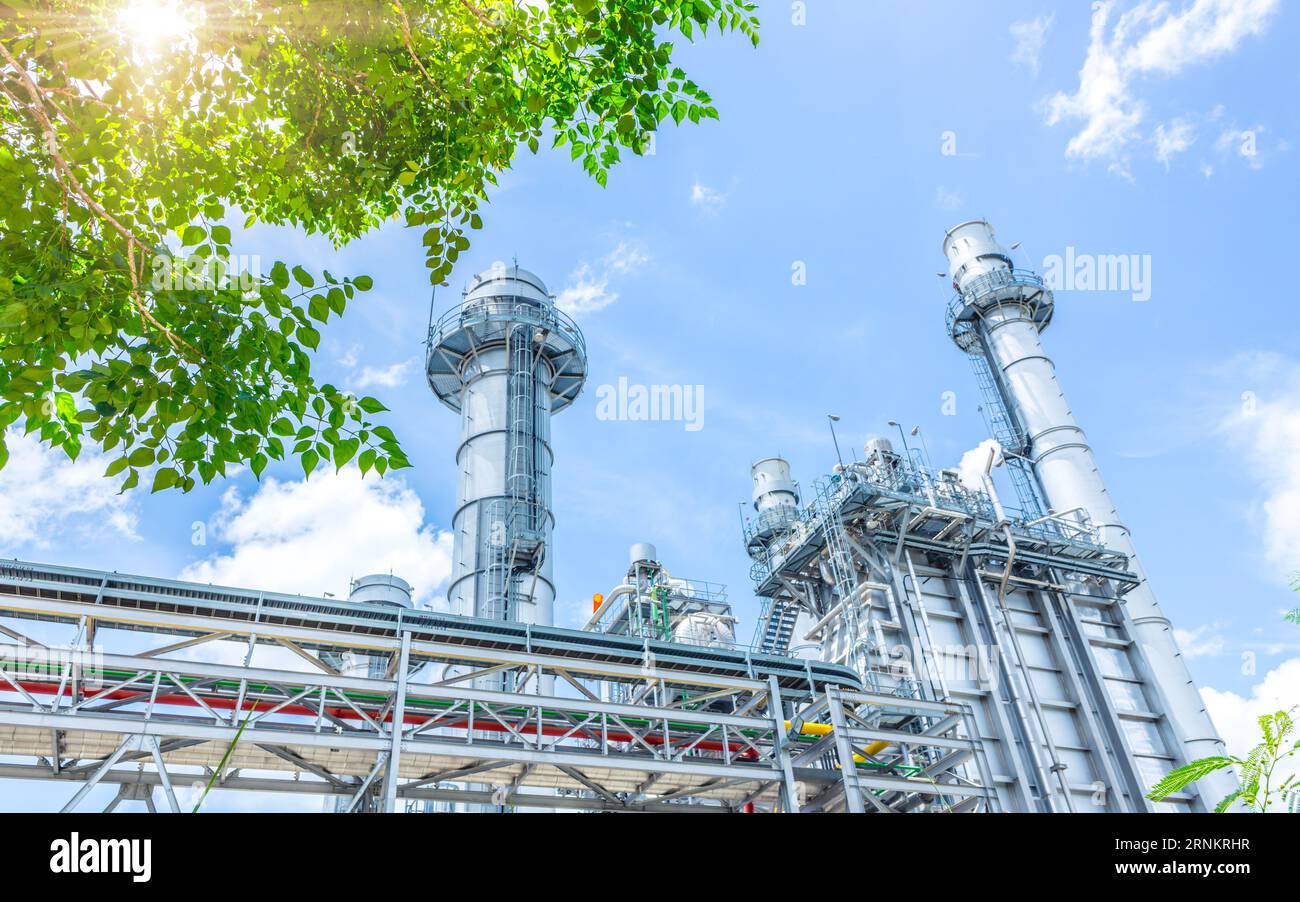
[1219,354,1300,576]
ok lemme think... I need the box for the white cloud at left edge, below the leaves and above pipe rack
[0,429,139,548]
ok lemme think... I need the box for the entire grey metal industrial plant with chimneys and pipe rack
[0,221,1231,814]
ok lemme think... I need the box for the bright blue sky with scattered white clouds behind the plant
[0,0,1300,811]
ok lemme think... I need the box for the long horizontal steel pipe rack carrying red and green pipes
[0,563,997,812]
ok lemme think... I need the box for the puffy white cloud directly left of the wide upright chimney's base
[181,467,451,602]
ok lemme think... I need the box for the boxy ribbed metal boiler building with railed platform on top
[753,464,1203,811]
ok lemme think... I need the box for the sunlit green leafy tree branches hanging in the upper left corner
[0,0,758,491]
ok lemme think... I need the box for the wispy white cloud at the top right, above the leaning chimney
[1044,0,1278,174]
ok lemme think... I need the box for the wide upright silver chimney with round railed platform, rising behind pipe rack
[428,264,586,624]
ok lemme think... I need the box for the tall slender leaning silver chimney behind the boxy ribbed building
[944,222,1234,807]
